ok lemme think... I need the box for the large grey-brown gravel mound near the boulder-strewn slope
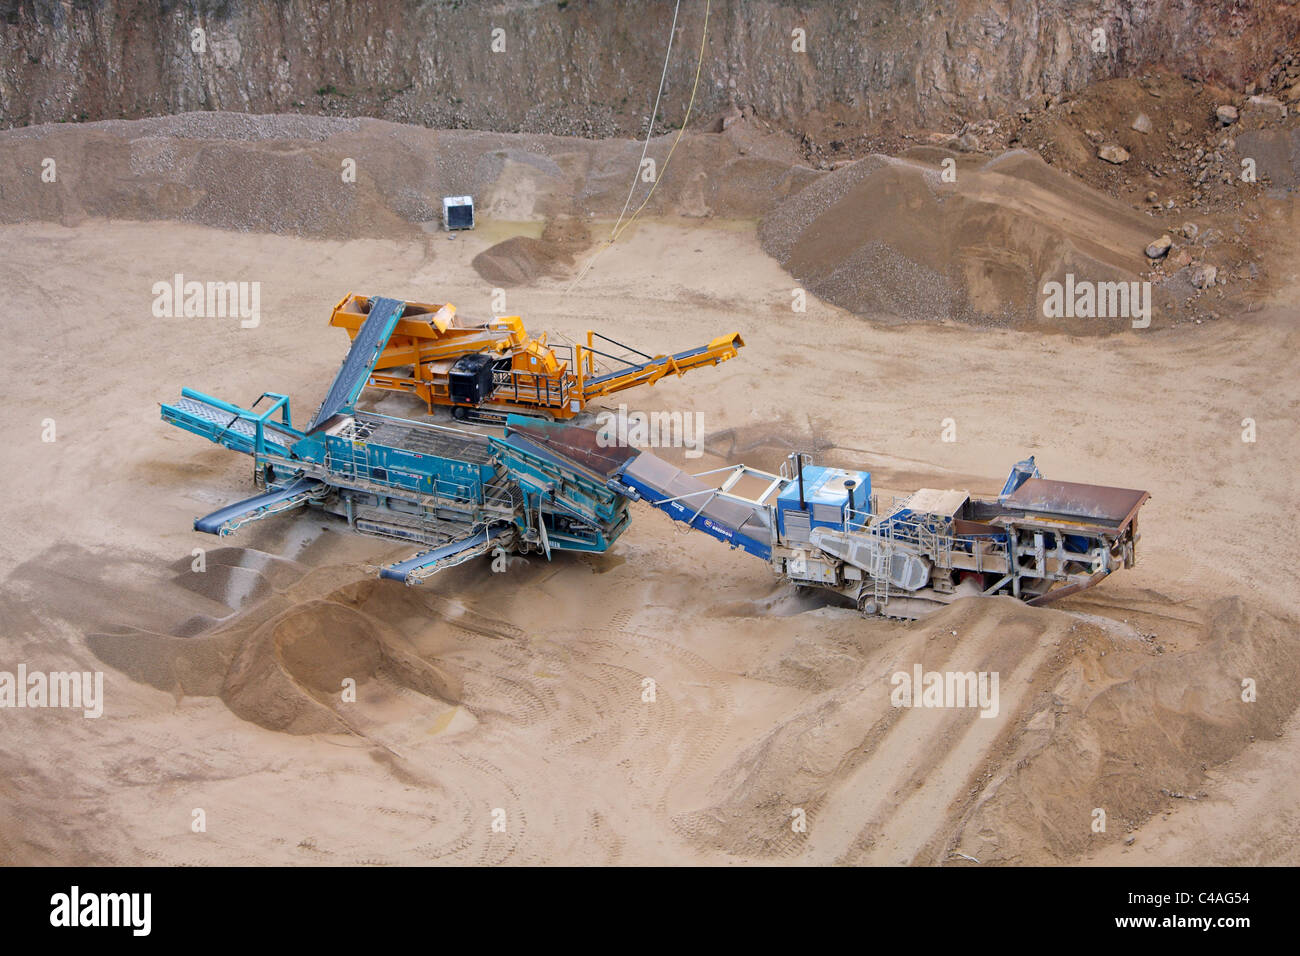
[761,150,1161,334]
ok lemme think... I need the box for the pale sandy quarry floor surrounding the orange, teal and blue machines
[0,138,1300,865]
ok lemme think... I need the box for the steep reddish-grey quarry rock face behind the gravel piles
[0,0,1300,135]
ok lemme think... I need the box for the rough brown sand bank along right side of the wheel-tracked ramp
[954,597,1300,864]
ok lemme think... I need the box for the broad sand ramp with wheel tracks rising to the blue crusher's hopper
[673,598,1300,864]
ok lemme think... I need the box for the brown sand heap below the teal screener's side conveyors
[81,548,459,734]
